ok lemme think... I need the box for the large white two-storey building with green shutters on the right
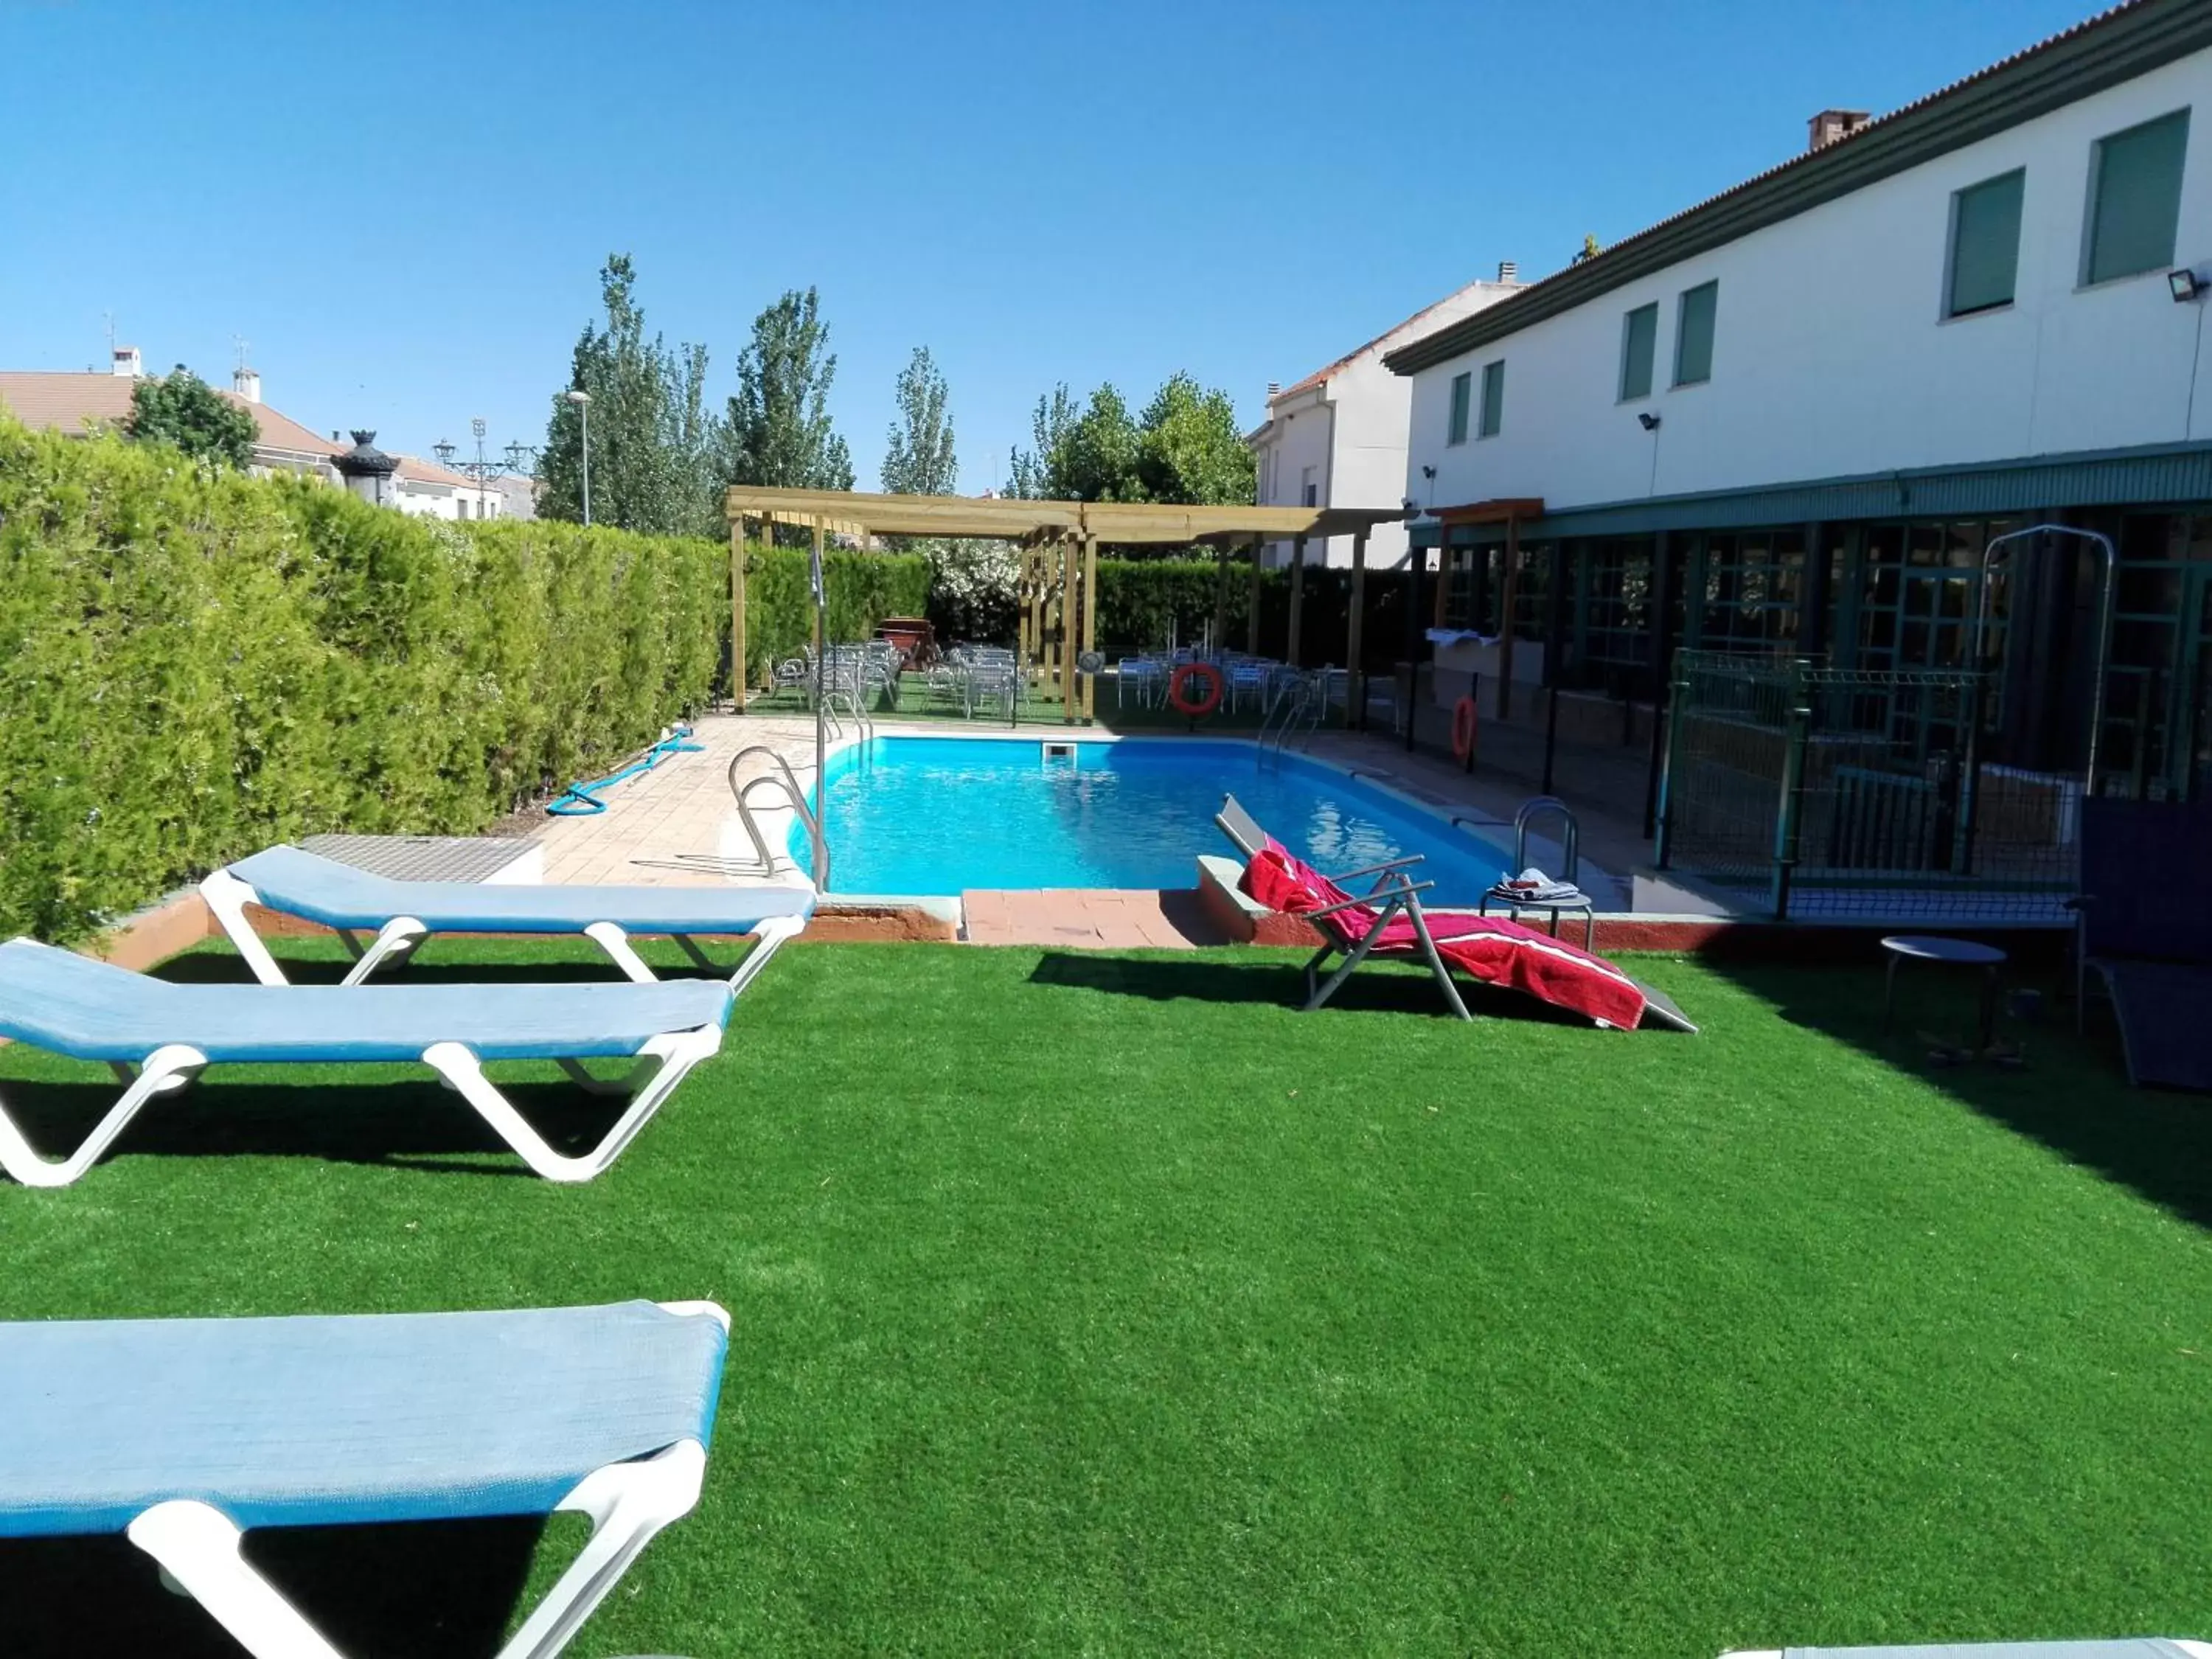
[1389,0,2212,792]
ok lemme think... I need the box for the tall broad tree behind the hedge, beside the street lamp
[538,254,723,535]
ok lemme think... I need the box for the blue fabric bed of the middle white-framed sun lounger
[0,940,730,1062]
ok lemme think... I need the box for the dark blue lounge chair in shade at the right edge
[2073,799,2212,1088]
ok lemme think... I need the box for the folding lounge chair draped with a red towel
[1214,796,1697,1031]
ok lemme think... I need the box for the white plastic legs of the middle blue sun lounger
[0,1024,721,1186]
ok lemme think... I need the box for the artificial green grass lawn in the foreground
[0,942,2212,1659]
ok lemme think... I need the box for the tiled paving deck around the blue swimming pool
[518,714,1721,949]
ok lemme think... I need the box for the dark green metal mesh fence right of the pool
[1655,650,2081,922]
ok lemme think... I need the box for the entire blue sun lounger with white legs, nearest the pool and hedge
[199,847,814,991]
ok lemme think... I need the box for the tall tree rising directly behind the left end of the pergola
[728,288,852,513]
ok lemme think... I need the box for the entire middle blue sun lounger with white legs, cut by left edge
[0,938,737,1186]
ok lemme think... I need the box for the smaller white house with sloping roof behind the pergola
[1245,265,1520,568]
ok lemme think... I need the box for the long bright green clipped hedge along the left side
[0,418,728,940]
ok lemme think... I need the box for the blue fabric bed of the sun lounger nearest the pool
[230,847,814,933]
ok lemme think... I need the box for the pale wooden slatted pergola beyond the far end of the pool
[723,484,1405,723]
